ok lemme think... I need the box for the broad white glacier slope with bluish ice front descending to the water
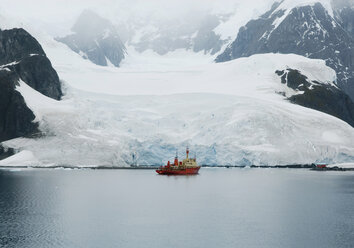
[0,47,354,166]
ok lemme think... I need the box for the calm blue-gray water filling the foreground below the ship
[0,168,354,248]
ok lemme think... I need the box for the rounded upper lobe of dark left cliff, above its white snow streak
[0,29,62,100]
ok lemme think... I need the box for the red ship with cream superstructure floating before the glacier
[156,147,200,175]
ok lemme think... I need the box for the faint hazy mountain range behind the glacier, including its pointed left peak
[53,10,246,58]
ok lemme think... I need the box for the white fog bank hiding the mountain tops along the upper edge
[0,0,274,36]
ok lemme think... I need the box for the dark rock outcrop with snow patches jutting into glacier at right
[276,69,354,127]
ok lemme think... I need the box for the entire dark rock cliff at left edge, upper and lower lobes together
[0,26,62,143]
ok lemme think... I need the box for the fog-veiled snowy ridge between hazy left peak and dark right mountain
[121,0,272,55]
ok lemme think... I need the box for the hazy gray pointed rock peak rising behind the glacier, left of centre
[56,10,126,67]
